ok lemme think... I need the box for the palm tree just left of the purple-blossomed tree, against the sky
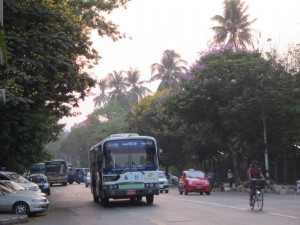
[150,50,187,91]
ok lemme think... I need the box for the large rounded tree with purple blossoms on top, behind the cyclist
[165,49,299,183]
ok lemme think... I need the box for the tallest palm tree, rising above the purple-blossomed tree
[211,0,256,50]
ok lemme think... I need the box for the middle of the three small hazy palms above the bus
[107,70,129,110]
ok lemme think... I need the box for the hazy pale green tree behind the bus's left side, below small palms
[59,102,128,166]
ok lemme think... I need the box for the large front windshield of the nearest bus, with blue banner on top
[103,139,157,173]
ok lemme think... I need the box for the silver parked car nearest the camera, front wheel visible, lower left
[0,184,49,215]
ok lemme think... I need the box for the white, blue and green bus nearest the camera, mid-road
[89,134,159,205]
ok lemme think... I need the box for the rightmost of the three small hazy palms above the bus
[125,67,151,106]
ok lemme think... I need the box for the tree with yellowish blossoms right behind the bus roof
[129,89,189,171]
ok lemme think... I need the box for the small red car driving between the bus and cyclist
[178,169,210,195]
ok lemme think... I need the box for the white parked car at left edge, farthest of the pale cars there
[0,171,40,191]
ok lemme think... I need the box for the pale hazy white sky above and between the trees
[59,0,300,129]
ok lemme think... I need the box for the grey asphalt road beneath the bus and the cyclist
[29,184,300,225]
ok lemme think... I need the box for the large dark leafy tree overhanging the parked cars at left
[0,0,127,172]
